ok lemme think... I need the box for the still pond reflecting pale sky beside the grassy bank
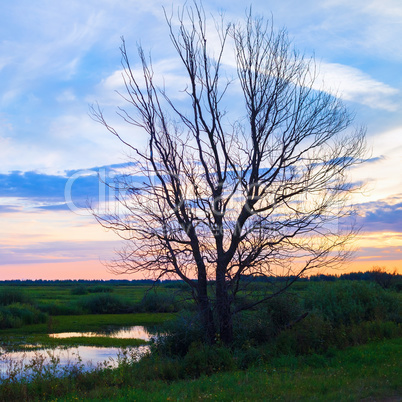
[0,326,153,381]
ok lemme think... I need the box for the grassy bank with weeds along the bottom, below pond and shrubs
[0,339,402,401]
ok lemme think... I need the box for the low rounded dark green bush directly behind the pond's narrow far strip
[77,293,133,314]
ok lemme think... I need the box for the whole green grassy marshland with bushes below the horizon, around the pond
[0,281,402,401]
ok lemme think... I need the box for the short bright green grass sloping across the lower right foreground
[58,338,402,401]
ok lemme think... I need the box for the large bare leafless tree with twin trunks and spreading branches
[92,4,365,343]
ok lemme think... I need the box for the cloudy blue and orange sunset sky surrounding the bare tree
[0,0,402,280]
